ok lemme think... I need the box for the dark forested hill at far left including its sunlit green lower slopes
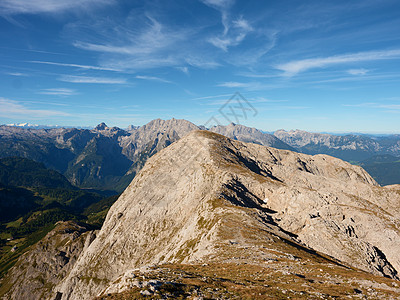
[0,157,118,282]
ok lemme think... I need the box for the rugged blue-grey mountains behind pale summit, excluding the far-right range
[0,119,291,192]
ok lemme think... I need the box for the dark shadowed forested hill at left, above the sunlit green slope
[0,157,109,223]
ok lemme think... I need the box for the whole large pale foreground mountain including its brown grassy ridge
[5,131,400,299]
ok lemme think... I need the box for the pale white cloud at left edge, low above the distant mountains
[0,98,69,119]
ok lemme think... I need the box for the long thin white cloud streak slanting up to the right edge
[276,50,400,76]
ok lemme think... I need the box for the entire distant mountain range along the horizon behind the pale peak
[0,119,400,192]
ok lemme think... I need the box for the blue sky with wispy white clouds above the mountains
[0,0,400,133]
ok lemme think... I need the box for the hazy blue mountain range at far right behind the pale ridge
[274,130,400,162]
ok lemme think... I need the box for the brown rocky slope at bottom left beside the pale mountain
[1,221,96,300]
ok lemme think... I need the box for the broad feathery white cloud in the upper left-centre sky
[73,15,191,70]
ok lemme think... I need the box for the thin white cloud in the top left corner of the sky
[0,0,115,16]
